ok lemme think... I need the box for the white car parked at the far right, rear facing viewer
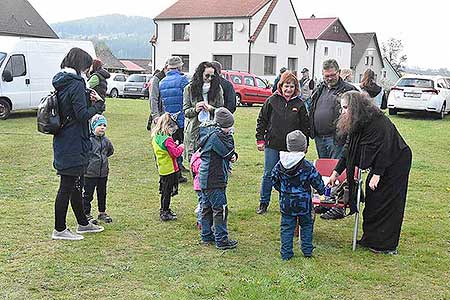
[387,75,450,119]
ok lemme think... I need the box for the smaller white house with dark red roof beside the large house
[299,16,354,80]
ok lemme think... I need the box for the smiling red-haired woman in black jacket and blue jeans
[256,71,309,214]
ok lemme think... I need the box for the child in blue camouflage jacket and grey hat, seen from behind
[272,130,325,260]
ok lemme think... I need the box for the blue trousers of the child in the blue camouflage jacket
[280,213,314,260]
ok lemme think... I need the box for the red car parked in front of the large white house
[222,70,272,106]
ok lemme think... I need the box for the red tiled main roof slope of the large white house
[155,0,272,20]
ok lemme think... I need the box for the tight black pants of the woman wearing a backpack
[55,175,89,231]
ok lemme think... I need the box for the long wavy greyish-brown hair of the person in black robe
[336,91,384,135]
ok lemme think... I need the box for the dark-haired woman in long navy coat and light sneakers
[52,48,105,240]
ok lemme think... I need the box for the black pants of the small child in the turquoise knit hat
[83,177,108,215]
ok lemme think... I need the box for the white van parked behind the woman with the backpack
[0,36,96,119]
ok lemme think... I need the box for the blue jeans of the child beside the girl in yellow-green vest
[201,188,228,244]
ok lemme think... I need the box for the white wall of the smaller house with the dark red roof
[308,40,352,81]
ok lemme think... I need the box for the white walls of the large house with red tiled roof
[153,0,311,81]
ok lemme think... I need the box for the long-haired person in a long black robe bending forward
[329,91,412,254]
